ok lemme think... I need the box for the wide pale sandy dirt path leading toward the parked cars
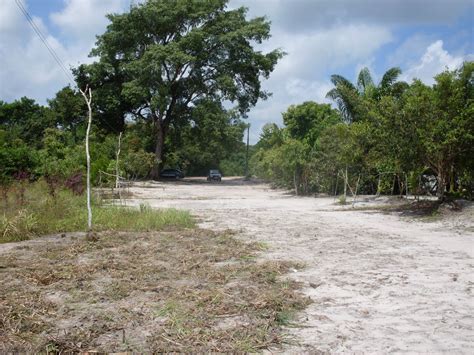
[131,179,474,354]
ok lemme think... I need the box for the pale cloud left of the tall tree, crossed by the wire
[0,0,128,104]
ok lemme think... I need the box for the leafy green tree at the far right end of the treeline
[404,62,474,200]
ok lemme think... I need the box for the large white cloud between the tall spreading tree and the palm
[243,25,392,143]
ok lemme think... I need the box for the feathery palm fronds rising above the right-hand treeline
[326,68,408,123]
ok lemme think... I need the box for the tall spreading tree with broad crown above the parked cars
[76,0,283,177]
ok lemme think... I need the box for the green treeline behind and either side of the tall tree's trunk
[0,87,250,189]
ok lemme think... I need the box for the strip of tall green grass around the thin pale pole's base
[0,182,194,243]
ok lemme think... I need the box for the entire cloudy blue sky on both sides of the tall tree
[0,0,474,143]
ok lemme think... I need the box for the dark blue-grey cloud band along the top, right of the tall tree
[230,0,473,33]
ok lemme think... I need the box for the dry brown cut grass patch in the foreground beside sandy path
[0,230,309,352]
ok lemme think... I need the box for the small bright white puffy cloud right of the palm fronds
[402,40,468,85]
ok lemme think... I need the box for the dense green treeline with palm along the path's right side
[252,62,474,199]
